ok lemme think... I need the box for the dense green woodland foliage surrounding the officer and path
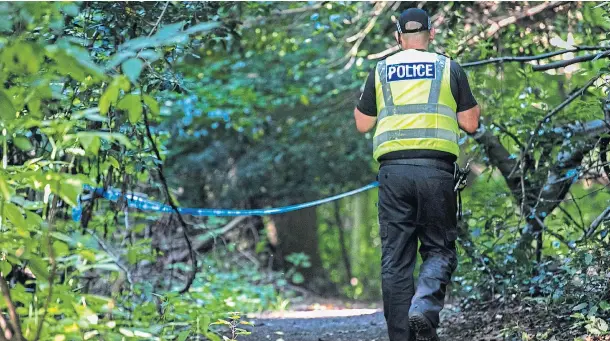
[0,2,610,341]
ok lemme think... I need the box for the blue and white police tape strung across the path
[72,181,379,221]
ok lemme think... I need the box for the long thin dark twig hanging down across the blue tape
[142,111,197,294]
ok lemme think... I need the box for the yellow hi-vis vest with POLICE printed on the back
[373,50,460,160]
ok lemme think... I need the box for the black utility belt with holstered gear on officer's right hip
[380,159,470,220]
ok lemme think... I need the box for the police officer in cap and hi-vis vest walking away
[354,8,480,341]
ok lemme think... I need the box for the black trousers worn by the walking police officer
[378,164,457,341]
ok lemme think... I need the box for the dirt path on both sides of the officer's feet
[238,300,610,341]
